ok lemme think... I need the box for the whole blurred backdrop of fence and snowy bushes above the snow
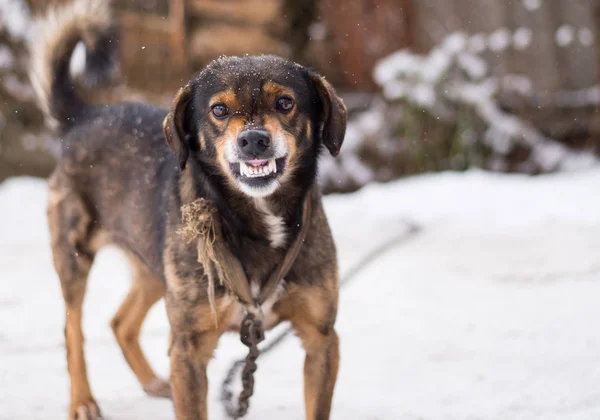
[0,0,600,192]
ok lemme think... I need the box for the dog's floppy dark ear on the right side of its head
[310,72,347,156]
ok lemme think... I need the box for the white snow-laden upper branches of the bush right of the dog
[374,30,596,172]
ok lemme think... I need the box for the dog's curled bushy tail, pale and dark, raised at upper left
[29,0,118,130]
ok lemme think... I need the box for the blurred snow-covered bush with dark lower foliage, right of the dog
[321,30,598,189]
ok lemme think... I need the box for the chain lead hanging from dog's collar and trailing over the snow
[221,222,421,419]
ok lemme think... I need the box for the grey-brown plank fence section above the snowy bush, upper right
[412,0,598,93]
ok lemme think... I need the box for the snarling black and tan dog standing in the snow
[32,0,346,420]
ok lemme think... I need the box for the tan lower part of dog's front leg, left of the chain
[170,331,220,420]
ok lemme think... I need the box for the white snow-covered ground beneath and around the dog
[0,170,600,420]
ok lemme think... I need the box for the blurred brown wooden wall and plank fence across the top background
[116,0,599,93]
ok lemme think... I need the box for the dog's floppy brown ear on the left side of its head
[163,86,192,171]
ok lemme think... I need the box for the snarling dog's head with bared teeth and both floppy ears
[163,56,346,197]
